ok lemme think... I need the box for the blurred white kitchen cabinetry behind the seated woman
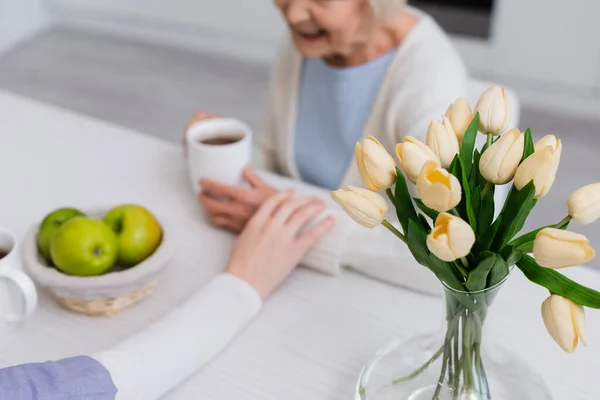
[48,0,600,116]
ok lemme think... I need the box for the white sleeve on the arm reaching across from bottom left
[93,274,262,400]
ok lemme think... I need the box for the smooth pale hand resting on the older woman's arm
[227,191,335,300]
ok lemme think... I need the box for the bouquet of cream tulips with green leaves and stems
[332,86,600,398]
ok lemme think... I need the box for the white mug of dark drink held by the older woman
[185,118,252,194]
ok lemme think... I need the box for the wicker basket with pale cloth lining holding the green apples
[22,210,174,317]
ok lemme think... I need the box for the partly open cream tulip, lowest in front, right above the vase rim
[427,213,475,262]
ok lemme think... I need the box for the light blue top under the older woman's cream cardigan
[294,49,396,190]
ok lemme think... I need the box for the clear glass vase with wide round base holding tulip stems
[355,281,552,400]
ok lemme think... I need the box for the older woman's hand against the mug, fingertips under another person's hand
[198,167,277,233]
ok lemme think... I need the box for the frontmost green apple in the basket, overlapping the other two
[50,217,117,276]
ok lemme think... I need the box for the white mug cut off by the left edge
[0,228,37,333]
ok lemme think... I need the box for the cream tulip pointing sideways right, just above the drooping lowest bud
[533,228,595,268]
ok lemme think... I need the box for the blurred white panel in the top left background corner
[0,0,48,53]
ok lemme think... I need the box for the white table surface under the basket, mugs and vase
[0,92,600,400]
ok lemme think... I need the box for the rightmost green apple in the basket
[104,204,162,267]
